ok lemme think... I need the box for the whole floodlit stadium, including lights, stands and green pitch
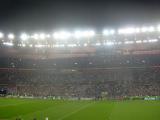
[0,25,160,120]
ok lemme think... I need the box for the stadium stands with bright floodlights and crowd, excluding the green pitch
[0,26,160,99]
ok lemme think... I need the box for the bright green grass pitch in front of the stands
[0,98,160,120]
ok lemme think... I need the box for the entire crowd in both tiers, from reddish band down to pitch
[0,55,160,98]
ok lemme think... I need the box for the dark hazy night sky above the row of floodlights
[0,0,160,31]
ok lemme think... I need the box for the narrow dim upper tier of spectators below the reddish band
[0,54,160,69]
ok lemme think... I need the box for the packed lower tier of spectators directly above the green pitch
[0,66,160,98]
